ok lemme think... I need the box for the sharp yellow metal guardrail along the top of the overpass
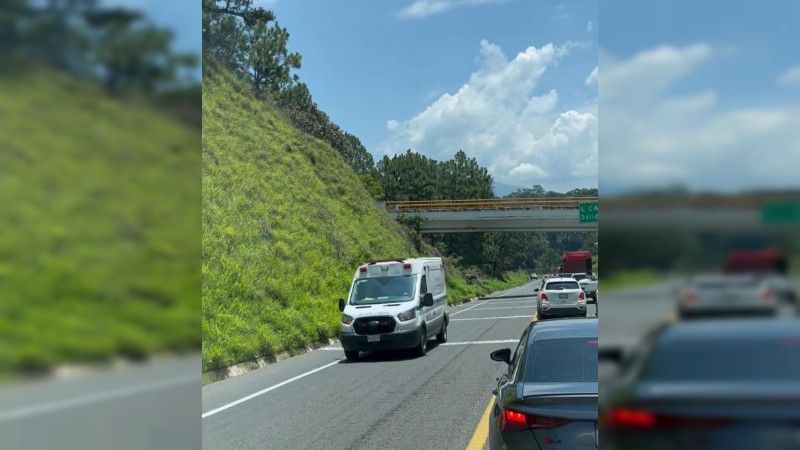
[386,197,597,212]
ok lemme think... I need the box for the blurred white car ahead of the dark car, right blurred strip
[678,275,778,318]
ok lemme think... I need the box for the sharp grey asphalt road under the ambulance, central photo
[202,284,594,450]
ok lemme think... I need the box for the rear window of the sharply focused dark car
[524,337,597,383]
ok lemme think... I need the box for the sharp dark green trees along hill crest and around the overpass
[203,0,597,274]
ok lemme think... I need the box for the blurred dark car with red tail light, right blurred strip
[600,319,800,450]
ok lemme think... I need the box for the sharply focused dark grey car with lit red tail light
[489,318,598,450]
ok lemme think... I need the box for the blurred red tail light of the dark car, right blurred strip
[601,408,733,429]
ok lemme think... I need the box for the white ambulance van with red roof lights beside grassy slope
[339,258,449,360]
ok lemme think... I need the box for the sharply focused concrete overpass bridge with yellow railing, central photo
[385,197,597,234]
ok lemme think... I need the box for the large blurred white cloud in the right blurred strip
[599,44,800,193]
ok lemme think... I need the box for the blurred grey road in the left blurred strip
[0,354,202,450]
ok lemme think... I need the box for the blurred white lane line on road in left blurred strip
[0,373,200,422]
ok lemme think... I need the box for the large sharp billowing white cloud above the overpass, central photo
[379,40,597,190]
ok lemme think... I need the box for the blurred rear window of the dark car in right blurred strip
[643,336,800,382]
